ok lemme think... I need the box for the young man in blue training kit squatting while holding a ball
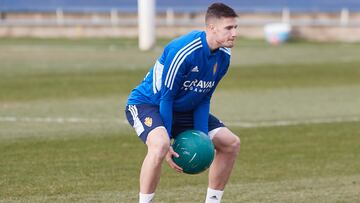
[125,3,240,203]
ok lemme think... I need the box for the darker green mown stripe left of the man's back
[0,69,146,101]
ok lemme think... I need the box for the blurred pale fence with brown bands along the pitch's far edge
[0,8,360,41]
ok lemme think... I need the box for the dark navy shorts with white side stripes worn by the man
[125,104,225,143]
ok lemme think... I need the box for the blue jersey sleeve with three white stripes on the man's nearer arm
[160,50,186,137]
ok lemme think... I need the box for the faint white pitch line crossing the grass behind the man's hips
[0,116,360,128]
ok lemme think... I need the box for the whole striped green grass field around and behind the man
[0,39,360,203]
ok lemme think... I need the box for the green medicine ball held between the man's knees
[172,130,215,174]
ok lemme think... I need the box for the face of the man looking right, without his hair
[213,18,238,48]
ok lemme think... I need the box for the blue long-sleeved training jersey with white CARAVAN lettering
[128,31,231,135]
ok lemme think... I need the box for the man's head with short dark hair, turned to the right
[205,3,238,49]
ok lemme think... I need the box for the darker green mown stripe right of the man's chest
[221,62,360,89]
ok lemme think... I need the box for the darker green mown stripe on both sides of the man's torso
[0,63,360,100]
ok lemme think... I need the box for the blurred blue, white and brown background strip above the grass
[0,0,360,42]
